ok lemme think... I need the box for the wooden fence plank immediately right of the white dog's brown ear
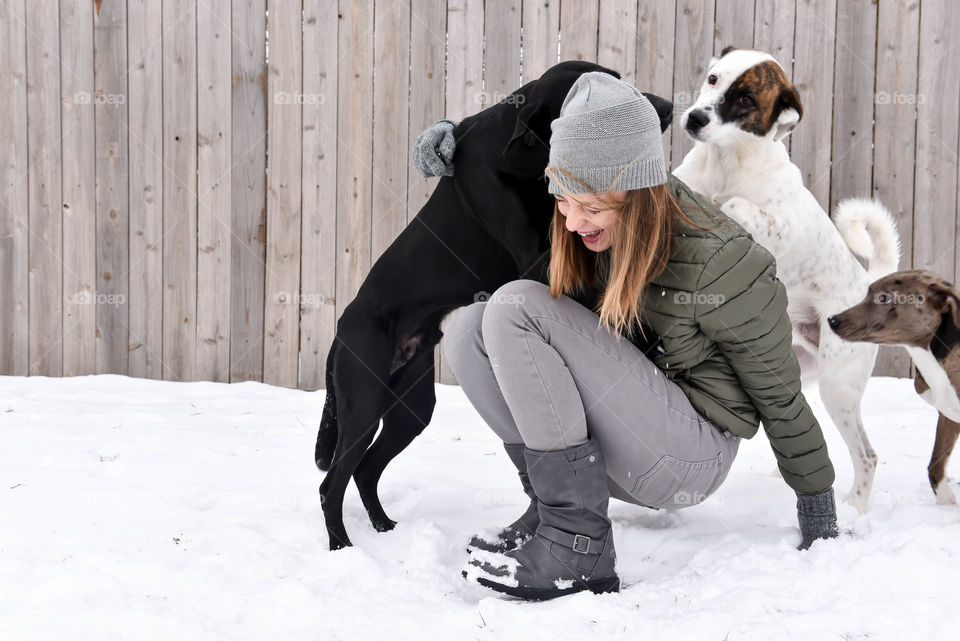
[790,0,837,211]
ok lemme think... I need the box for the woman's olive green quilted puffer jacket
[608,174,834,493]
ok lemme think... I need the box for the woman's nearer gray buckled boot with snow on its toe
[464,440,620,600]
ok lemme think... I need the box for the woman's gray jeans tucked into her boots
[443,280,740,508]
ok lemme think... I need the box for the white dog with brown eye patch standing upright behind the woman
[674,47,900,513]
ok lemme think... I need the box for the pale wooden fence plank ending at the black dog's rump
[336,2,372,360]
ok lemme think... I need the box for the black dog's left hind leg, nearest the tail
[320,328,393,550]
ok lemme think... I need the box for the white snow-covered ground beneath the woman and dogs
[0,376,960,641]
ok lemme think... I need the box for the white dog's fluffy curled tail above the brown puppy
[833,198,900,281]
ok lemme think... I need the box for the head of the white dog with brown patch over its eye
[680,47,803,145]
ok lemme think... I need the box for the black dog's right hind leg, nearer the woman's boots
[354,348,437,532]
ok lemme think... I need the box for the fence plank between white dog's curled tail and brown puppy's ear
[873,0,920,377]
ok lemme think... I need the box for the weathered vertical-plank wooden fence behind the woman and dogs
[0,0,960,389]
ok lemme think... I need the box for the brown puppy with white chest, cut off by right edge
[827,269,960,504]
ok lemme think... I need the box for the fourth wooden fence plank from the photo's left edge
[93,2,130,374]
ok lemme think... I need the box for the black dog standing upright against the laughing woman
[315,61,673,550]
